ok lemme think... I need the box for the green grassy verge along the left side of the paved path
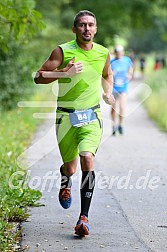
[0,85,55,251]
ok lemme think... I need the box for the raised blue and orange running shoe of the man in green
[59,188,72,209]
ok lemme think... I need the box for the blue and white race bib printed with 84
[70,109,97,127]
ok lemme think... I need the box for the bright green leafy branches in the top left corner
[0,0,44,53]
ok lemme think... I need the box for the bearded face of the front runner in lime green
[73,16,97,42]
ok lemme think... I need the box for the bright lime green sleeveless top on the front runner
[57,40,108,109]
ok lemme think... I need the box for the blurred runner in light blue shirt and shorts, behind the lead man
[110,45,133,135]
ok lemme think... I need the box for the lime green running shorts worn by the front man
[56,108,102,163]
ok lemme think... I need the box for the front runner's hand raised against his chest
[63,57,83,76]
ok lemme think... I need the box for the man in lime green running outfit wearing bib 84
[34,10,115,236]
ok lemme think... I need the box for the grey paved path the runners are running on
[23,80,167,252]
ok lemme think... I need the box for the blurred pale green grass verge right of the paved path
[145,69,167,132]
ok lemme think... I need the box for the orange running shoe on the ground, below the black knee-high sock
[75,215,89,237]
